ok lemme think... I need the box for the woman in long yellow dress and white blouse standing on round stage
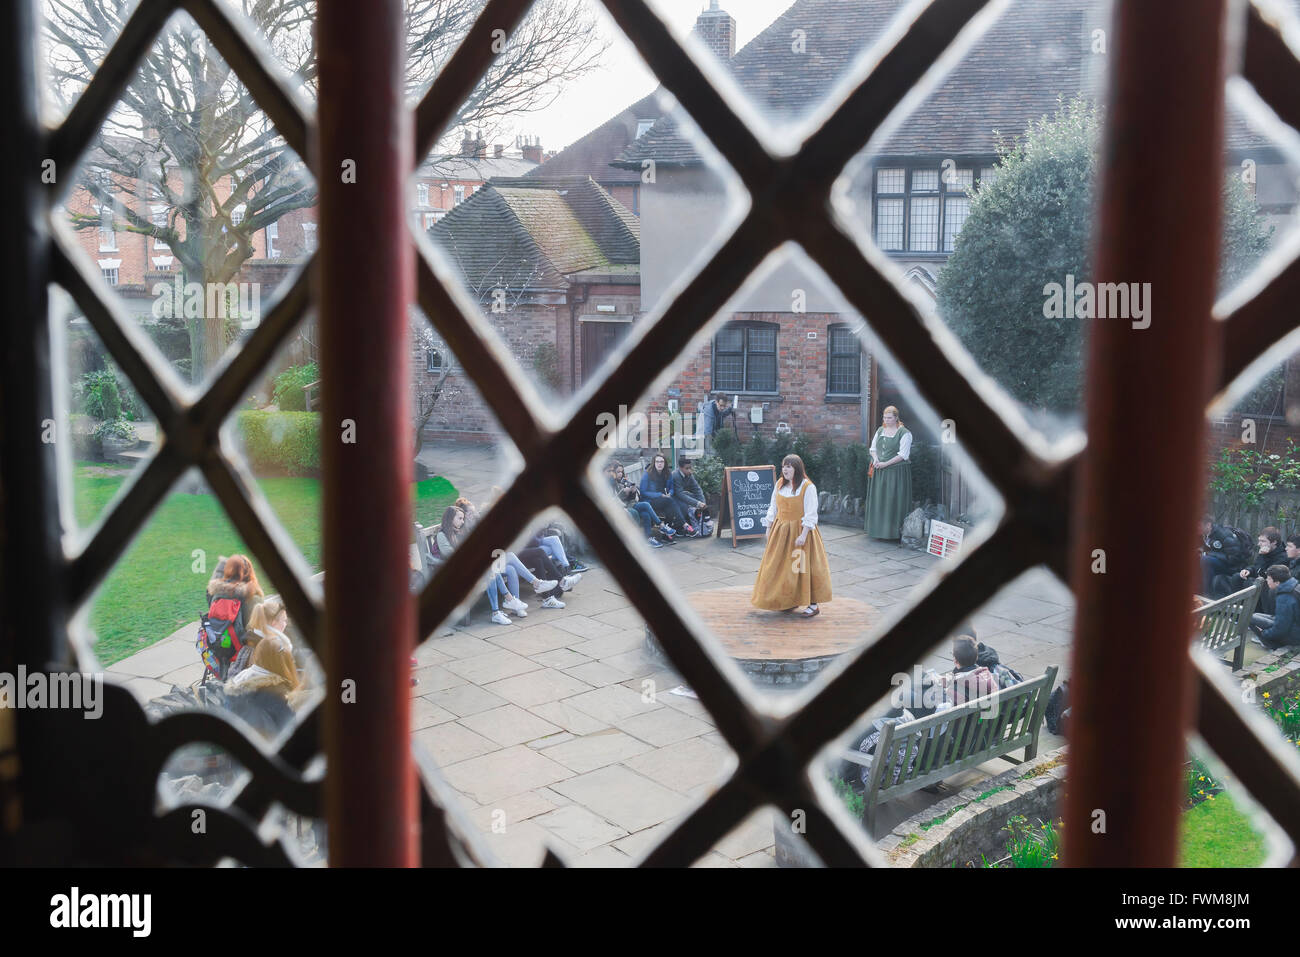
[750,455,831,618]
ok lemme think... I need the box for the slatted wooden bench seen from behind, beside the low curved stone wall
[841,664,1057,836]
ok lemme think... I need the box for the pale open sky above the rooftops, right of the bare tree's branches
[506,0,794,152]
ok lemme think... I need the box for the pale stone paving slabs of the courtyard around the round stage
[109,446,1257,867]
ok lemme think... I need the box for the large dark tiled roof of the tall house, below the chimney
[616,0,1296,169]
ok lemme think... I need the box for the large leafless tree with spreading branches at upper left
[43,0,605,381]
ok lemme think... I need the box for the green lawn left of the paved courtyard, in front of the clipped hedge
[73,463,458,664]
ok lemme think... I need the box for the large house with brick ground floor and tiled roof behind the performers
[615,0,1300,478]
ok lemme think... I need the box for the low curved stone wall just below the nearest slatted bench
[876,748,1066,867]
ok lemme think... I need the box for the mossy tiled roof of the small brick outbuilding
[429,177,641,298]
